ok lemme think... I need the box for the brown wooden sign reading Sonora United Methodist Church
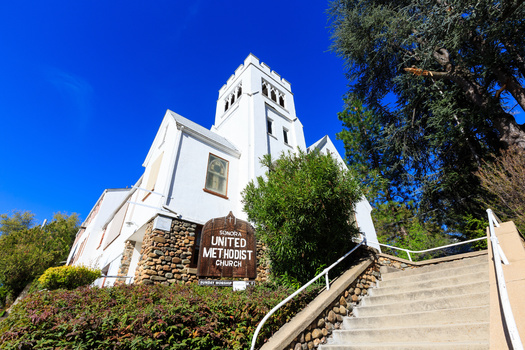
[197,212,257,279]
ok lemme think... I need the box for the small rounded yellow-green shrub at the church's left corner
[38,266,101,290]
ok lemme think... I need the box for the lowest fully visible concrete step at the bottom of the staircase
[332,322,489,345]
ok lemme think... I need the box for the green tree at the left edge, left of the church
[0,213,79,296]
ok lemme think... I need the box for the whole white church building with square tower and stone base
[68,54,379,285]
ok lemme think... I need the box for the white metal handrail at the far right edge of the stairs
[487,209,523,350]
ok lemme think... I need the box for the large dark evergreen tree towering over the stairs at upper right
[330,0,525,228]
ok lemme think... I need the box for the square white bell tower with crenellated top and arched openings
[212,54,306,182]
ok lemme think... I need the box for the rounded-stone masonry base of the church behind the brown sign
[134,219,268,285]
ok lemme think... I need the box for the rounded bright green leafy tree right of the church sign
[242,151,361,284]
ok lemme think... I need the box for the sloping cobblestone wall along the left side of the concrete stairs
[286,261,381,350]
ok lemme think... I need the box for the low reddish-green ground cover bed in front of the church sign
[0,285,317,349]
